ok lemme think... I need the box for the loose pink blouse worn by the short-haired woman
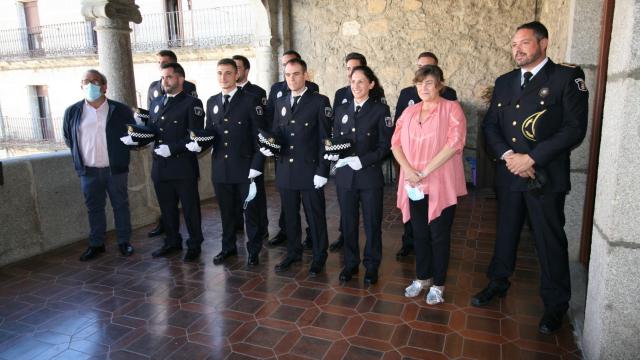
[391,98,467,223]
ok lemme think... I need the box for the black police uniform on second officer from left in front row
[205,89,264,255]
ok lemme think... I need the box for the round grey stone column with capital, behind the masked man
[82,0,142,106]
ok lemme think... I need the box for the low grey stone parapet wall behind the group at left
[0,149,213,266]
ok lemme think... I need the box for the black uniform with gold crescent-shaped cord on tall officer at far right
[483,60,589,314]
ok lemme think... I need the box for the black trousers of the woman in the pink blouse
[409,195,456,286]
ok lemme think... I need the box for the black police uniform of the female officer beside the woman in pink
[333,98,393,273]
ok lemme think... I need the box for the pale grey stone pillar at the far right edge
[582,0,640,359]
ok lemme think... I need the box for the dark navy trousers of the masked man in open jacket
[80,166,131,247]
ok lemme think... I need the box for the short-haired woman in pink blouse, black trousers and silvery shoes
[391,65,467,305]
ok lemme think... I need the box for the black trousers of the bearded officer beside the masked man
[153,178,203,249]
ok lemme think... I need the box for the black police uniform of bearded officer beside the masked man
[149,91,204,250]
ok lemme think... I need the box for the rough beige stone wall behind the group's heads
[291,0,536,175]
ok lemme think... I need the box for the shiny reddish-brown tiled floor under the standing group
[0,184,581,360]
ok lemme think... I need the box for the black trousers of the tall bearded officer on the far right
[487,187,571,312]
